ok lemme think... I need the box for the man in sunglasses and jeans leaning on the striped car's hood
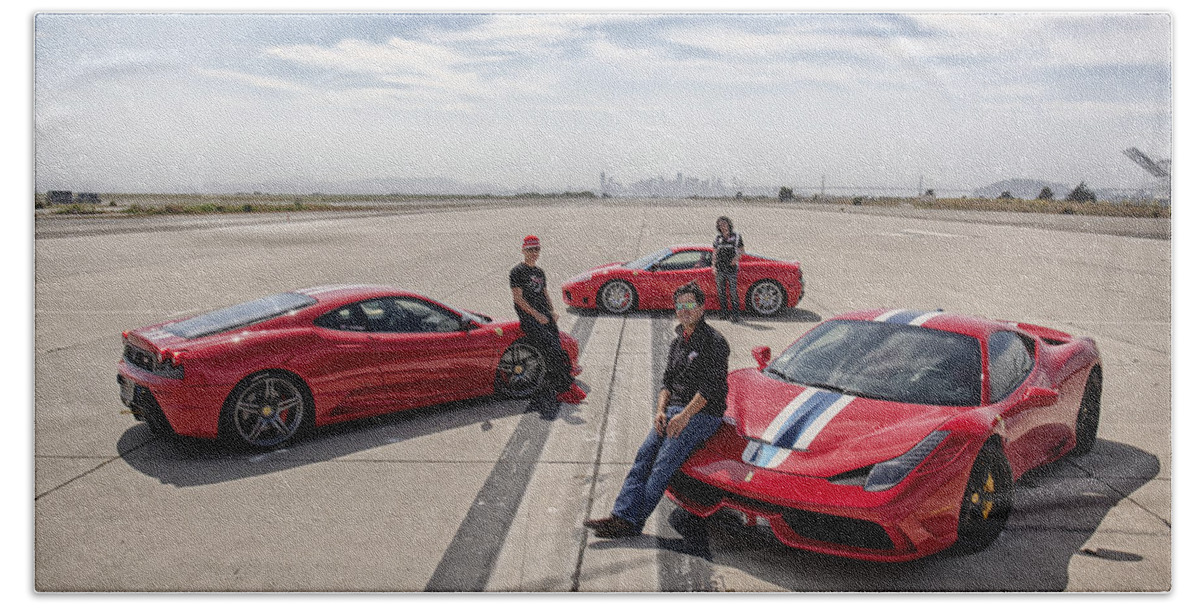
[583,281,730,538]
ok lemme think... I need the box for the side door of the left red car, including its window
[371,296,496,409]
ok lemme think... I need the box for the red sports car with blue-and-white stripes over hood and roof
[667,309,1103,561]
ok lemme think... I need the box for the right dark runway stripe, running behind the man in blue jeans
[649,317,714,591]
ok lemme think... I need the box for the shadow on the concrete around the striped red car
[659,440,1156,591]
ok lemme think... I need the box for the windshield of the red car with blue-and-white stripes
[763,320,983,405]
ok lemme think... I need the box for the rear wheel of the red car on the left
[221,372,313,450]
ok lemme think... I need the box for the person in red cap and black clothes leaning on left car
[509,235,574,420]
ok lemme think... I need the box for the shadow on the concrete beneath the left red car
[116,397,535,487]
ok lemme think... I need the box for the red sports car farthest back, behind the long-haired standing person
[563,245,804,315]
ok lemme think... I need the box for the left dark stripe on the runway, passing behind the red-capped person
[425,317,595,591]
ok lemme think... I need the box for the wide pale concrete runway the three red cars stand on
[34,200,1172,591]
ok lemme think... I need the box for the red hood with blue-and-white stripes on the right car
[726,369,962,477]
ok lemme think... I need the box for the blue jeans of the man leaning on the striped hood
[612,405,721,530]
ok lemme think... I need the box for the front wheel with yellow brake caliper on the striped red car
[955,441,1013,553]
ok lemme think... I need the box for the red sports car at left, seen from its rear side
[116,285,580,449]
